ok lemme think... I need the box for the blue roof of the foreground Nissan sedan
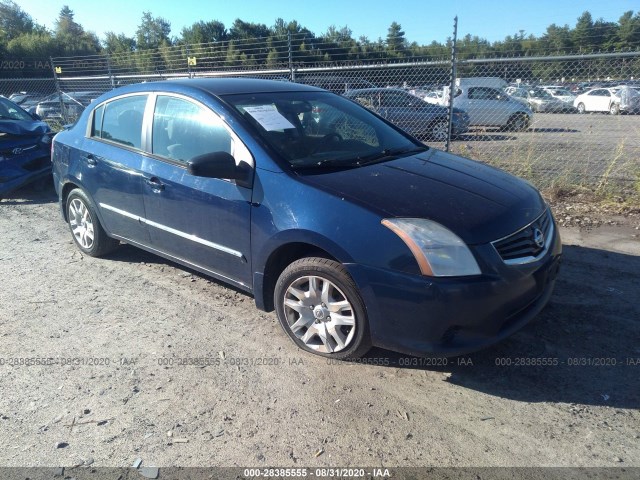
[110,78,321,96]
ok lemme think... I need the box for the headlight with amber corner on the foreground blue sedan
[382,218,481,277]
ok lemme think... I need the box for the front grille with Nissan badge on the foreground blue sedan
[492,209,553,264]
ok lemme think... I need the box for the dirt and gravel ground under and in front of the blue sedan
[0,182,640,467]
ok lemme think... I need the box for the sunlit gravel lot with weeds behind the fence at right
[436,113,640,193]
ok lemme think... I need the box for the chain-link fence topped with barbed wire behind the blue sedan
[2,34,640,199]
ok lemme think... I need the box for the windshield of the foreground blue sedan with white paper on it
[224,92,426,168]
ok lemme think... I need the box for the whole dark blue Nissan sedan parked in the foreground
[52,79,562,359]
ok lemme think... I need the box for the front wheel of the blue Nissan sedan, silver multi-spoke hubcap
[274,257,371,360]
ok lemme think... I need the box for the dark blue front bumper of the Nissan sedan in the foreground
[348,223,562,356]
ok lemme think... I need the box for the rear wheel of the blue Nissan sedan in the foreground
[66,188,120,257]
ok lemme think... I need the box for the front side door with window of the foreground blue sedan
[143,94,254,286]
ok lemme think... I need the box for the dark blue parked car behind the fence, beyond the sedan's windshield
[344,88,469,142]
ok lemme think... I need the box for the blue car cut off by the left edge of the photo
[0,98,51,198]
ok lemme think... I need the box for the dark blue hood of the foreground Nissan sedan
[301,149,546,245]
